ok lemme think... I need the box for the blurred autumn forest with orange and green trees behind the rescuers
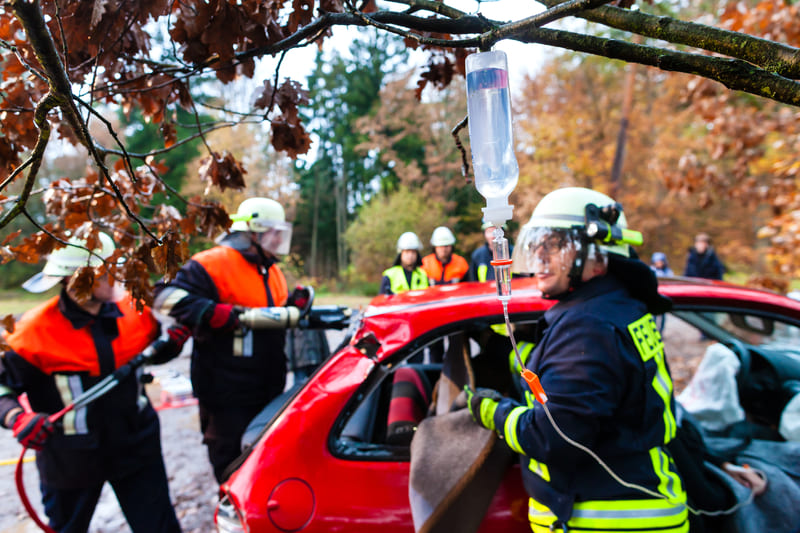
[0,1,800,310]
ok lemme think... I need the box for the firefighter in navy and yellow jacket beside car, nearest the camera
[467,188,688,532]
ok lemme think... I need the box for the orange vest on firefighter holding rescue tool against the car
[192,246,289,307]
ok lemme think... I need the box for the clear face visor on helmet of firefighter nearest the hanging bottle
[511,226,583,274]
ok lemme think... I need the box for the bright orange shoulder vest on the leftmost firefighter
[6,295,159,376]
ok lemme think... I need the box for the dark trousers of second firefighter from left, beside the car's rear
[199,403,264,483]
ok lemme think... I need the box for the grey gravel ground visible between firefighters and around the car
[0,319,704,533]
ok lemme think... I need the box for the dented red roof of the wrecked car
[353,278,800,360]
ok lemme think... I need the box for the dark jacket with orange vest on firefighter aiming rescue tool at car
[155,241,288,407]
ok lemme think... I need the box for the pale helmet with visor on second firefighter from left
[230,197,292,255]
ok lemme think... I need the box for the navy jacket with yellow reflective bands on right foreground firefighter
[494,276,688,532]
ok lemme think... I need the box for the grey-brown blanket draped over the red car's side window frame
[408,335,514,533]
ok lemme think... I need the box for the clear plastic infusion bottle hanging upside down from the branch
[467,50,519,224]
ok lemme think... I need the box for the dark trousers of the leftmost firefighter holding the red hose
[41,457,181,533]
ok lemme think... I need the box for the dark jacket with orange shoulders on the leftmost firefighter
[0,291,161,489]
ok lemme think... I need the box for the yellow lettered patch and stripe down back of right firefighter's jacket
[628,313,677,444]
